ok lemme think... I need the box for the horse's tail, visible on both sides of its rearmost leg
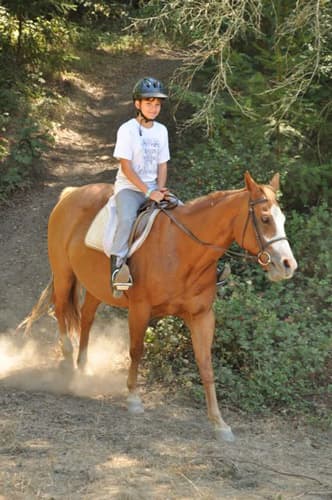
[17,275,81,334]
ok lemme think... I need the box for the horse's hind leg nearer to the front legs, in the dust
[77,291,100,370]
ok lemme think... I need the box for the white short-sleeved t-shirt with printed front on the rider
[114,118,170,194]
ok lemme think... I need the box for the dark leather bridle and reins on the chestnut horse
[156,195,288,267]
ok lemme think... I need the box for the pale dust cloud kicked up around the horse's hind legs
[0,319,129,397]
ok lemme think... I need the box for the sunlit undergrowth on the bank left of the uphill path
[0,2,144,202]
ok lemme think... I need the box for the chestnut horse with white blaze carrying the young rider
[22,172,297,441]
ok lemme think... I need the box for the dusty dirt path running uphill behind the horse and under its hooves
[0,47,332,500]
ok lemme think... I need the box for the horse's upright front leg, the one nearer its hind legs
[127,303,150,414]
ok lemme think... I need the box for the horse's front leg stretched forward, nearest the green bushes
[186,309,234,441]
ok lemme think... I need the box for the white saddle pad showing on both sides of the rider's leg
[84,197,160,257]
